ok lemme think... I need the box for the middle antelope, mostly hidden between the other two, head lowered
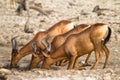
[30,24,89,69]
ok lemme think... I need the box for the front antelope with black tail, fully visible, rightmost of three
[42,23,111,69]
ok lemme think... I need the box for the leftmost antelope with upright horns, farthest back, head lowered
[10,20,74,68]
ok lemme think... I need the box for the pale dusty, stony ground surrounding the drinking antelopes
[0,0,120,80]
